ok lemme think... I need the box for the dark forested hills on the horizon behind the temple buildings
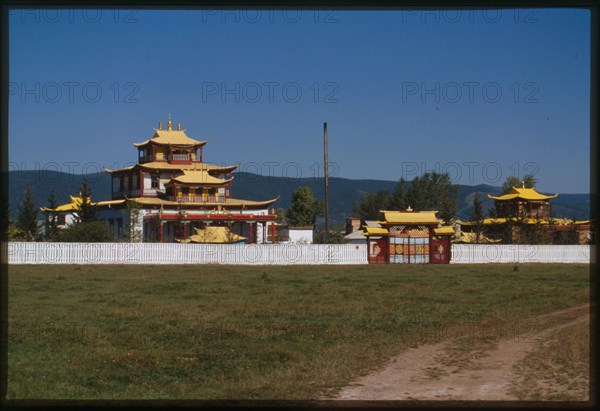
[8,170,590,224]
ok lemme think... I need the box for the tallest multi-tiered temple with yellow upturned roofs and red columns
[45,116,279,243]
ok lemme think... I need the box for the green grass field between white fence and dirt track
[8,264,590,400]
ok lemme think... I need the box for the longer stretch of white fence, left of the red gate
[8,242,367,264]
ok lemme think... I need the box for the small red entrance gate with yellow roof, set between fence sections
[363,208,454,264]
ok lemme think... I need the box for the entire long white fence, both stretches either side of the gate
[7,242,593,265]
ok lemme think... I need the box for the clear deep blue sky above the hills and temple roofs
[9,9,590,193]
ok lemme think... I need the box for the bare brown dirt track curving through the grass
[335,304,589,400]
